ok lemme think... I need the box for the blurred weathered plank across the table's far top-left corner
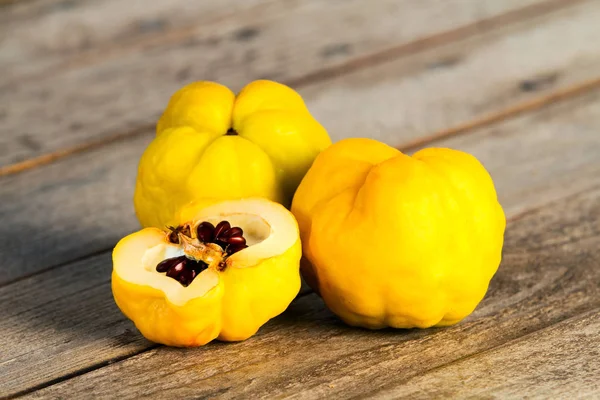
[0,0,272,79]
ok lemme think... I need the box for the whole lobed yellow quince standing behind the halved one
[134,80,331,228]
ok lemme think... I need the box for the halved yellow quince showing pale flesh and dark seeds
[112,199,301,346]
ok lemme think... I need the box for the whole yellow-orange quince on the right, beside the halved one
[292,139,506,329]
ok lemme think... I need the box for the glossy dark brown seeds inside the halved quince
[156,221,248,286]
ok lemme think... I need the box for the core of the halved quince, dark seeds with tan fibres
[156,220,248,286]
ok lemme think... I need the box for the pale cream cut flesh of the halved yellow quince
[113,198,292,305]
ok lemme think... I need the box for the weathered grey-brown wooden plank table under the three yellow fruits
[0,0,600,399]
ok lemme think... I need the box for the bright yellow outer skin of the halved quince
[111,200,302,347]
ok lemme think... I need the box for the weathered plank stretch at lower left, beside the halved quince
[0,253,155,397]
